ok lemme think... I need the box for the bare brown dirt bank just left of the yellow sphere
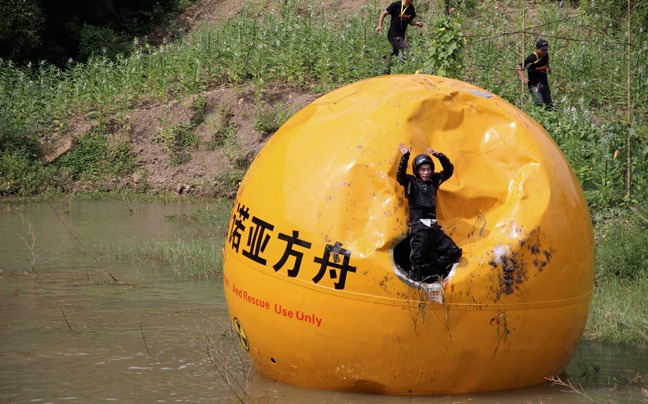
[119,86,318,197]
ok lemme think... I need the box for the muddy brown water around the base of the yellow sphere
[0,200,648,404]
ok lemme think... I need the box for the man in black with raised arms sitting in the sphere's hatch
[396,142,462,282]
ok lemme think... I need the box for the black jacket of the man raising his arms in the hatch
[396,152,454,223]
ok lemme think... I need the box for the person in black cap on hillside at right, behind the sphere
[516,39,553,110]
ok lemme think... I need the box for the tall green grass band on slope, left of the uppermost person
[0,2,384,126]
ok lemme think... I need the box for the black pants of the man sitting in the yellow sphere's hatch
[410,222,461,281]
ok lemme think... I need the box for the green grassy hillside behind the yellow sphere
[0,1,648,202]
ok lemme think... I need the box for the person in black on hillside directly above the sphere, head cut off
[376,0,423,71]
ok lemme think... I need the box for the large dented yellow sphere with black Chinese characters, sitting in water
[224,75,594,394]
